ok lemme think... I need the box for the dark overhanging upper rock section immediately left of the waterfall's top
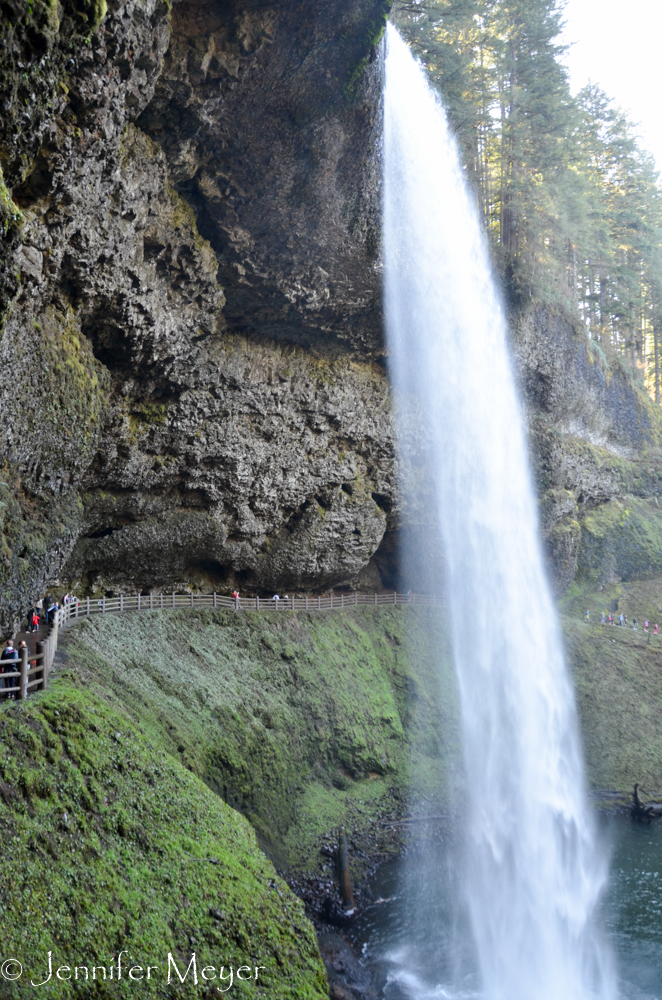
[138,0,390,357]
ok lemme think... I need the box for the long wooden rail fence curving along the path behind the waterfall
[0,591,438,701]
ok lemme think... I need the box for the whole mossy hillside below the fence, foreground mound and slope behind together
[0,607,459,1000]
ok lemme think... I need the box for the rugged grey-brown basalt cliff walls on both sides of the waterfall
[0,0,662,628]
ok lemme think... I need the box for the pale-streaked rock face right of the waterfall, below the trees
[513,309,662,593]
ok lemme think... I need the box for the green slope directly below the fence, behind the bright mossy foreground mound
[58,607,458,870]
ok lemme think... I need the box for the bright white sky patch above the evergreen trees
[562,0,662,171]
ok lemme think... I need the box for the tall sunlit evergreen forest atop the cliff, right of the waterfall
[394,0,662,403]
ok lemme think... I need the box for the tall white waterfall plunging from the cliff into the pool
[384,27,615,1000]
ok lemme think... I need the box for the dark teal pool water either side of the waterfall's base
[351,816,662,1000]
